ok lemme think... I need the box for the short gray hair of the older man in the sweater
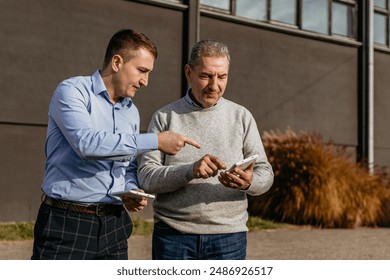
[188,40,230,68]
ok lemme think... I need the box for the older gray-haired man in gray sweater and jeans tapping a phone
[138,40,273,260]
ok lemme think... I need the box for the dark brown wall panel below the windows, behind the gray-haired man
[201,17,357,146]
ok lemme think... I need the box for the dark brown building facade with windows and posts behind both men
[0,0,390,222]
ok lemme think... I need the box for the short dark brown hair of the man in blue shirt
[103,29,158,68]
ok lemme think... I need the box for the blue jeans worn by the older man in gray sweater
[152,221,247,260]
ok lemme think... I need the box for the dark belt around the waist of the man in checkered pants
[43,195,124,216]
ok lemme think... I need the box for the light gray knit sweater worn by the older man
[138,98,273,234]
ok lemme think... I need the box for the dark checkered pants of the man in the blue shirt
[31,203,133,260]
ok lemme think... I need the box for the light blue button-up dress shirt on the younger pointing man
[42,71,158,203]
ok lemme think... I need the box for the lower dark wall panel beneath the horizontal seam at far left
[0,125,46,222]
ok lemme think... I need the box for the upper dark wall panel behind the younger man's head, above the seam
[0,0,182,127]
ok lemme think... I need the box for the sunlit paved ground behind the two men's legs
[0,227,390,260]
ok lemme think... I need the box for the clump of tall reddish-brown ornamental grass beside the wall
[248,130,390,228]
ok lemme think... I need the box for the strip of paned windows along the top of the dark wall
[200,0,356,38]
